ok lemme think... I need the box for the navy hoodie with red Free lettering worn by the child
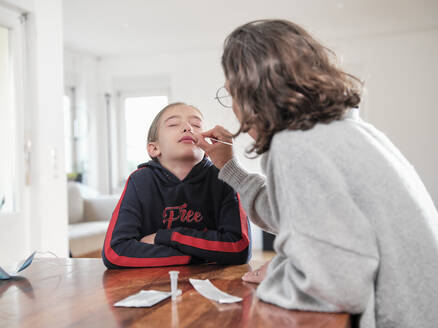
[102,159,251,269]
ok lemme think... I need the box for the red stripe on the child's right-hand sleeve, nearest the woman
[171,194,249,253]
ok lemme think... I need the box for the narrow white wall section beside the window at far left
[26,0,68,256]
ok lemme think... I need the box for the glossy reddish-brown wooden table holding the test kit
[0,258,350,328]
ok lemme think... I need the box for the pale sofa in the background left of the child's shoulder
[68,182,119,257]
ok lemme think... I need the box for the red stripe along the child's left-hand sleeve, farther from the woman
[104,169,190,267]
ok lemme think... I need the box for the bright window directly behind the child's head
[124,96,169,174]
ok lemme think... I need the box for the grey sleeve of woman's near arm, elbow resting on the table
[257,141,379,313]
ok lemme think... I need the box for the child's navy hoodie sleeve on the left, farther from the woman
[102,172,191,269]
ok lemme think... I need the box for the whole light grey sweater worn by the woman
[219,111,438,328]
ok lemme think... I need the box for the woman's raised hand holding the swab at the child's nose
[194,125,233,169]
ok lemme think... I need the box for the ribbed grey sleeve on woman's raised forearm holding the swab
[219,158,278,234]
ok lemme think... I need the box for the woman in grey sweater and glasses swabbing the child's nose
[197,20,438,327]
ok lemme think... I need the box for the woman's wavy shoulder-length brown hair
[222,20,362,154]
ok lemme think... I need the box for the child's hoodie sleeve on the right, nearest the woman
[155,186,250,264]
